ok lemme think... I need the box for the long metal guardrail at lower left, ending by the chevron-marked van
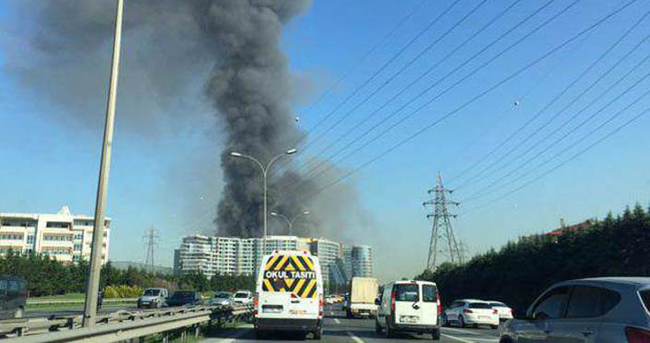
[0,306,253,343]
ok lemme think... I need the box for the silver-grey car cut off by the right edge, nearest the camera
[500,277,650,343]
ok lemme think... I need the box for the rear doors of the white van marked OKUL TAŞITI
[260,254,320,318]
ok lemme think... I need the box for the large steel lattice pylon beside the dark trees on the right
[422,174,463,271]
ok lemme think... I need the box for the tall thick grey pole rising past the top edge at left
[83,0,124,327]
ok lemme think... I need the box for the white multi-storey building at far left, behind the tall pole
[0,206,111,263]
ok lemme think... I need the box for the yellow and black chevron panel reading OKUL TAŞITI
[262,255,318,298]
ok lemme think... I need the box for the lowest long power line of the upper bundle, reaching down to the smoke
[298,0,637,203]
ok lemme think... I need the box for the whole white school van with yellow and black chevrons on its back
[254,251,325,339]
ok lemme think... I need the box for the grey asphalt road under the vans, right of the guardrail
[205,306,499,343]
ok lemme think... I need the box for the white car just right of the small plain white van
[442,299,499,329]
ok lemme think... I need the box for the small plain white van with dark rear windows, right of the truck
[375,281,442,340]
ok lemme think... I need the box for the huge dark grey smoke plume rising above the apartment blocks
[0,0,371,239]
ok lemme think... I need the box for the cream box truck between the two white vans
[345,277,379,318]
